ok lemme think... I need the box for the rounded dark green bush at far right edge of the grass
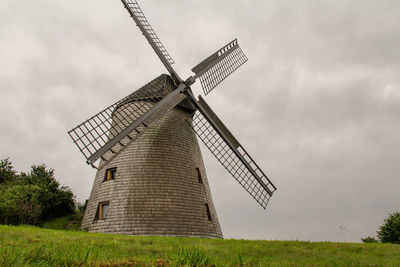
[378,212,400,244]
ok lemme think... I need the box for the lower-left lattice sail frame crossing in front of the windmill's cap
[68,76,170,168]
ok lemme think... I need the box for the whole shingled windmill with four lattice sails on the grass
[68,0,276,237]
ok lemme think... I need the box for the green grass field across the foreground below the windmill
[0,225,400,266]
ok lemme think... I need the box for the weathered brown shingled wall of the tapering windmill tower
[82,75,222,238]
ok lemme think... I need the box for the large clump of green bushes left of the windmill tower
[0,159,75,225]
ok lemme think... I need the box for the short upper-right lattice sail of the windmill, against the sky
[192,39,248,95]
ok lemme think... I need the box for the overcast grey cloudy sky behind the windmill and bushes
[0,0,400,242]
